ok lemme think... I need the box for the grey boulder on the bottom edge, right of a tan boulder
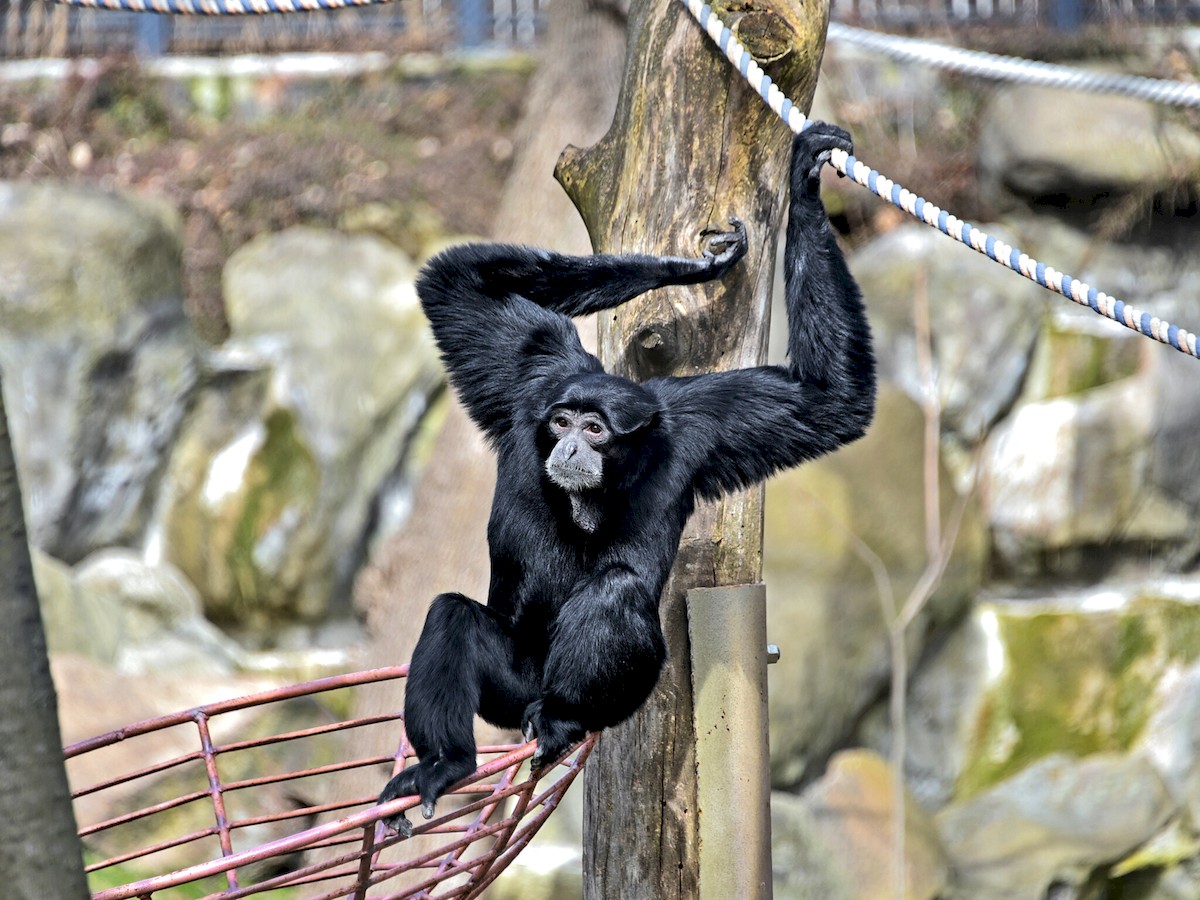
[936,755,1175,900]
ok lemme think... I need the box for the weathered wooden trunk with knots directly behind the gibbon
[557,0,828,900]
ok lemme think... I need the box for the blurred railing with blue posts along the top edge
[7,0,1200,59]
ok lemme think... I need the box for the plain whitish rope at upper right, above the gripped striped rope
[829,23,1200,107]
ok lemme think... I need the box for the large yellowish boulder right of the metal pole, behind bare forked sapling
[764,388,985,787]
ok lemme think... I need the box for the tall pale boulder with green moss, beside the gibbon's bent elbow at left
[161,228,443,642]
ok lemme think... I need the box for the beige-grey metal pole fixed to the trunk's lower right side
[688,584,772,900]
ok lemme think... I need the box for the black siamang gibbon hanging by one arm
[379,122,875,833]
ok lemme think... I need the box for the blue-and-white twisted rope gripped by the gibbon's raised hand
[679,0,1198,356]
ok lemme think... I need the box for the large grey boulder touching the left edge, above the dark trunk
[0,182,198,563]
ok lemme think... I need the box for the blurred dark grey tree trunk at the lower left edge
[0,369,89,900]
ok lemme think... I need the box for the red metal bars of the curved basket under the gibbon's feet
[64,666,595,900]
